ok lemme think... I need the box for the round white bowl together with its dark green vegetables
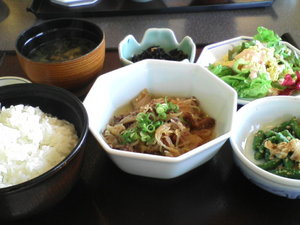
[230,96,300,199]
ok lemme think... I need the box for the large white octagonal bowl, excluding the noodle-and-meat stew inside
[84,60,237,179]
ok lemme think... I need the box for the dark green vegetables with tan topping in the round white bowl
[252,117,300,179]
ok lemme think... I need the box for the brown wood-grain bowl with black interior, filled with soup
[16,18,105,90]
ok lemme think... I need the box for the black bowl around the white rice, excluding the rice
[0,84,88,220]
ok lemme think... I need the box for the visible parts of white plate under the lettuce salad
[196,36,300,105]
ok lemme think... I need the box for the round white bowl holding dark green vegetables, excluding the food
[230,96,300,199]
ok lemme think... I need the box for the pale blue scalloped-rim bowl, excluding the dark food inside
[118,28,196,65]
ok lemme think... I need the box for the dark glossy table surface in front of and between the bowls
[0,51,300,225]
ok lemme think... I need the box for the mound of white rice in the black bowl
[0,105,78,188]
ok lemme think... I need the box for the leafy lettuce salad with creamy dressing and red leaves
[208,27,300,99]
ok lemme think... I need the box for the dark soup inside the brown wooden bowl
[28,37,97,62]
